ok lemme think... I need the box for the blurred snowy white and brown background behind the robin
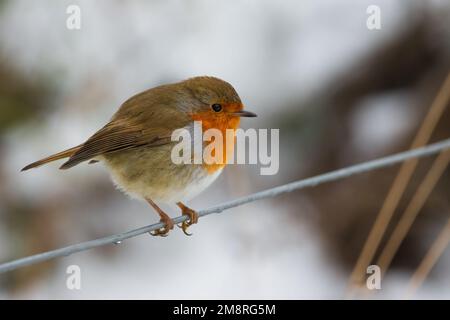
[0,0,450,299]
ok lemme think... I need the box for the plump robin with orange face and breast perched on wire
[22,76,256,237]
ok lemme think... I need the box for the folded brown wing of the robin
[61,92,189,169]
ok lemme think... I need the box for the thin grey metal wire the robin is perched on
[0,139,450,273]
